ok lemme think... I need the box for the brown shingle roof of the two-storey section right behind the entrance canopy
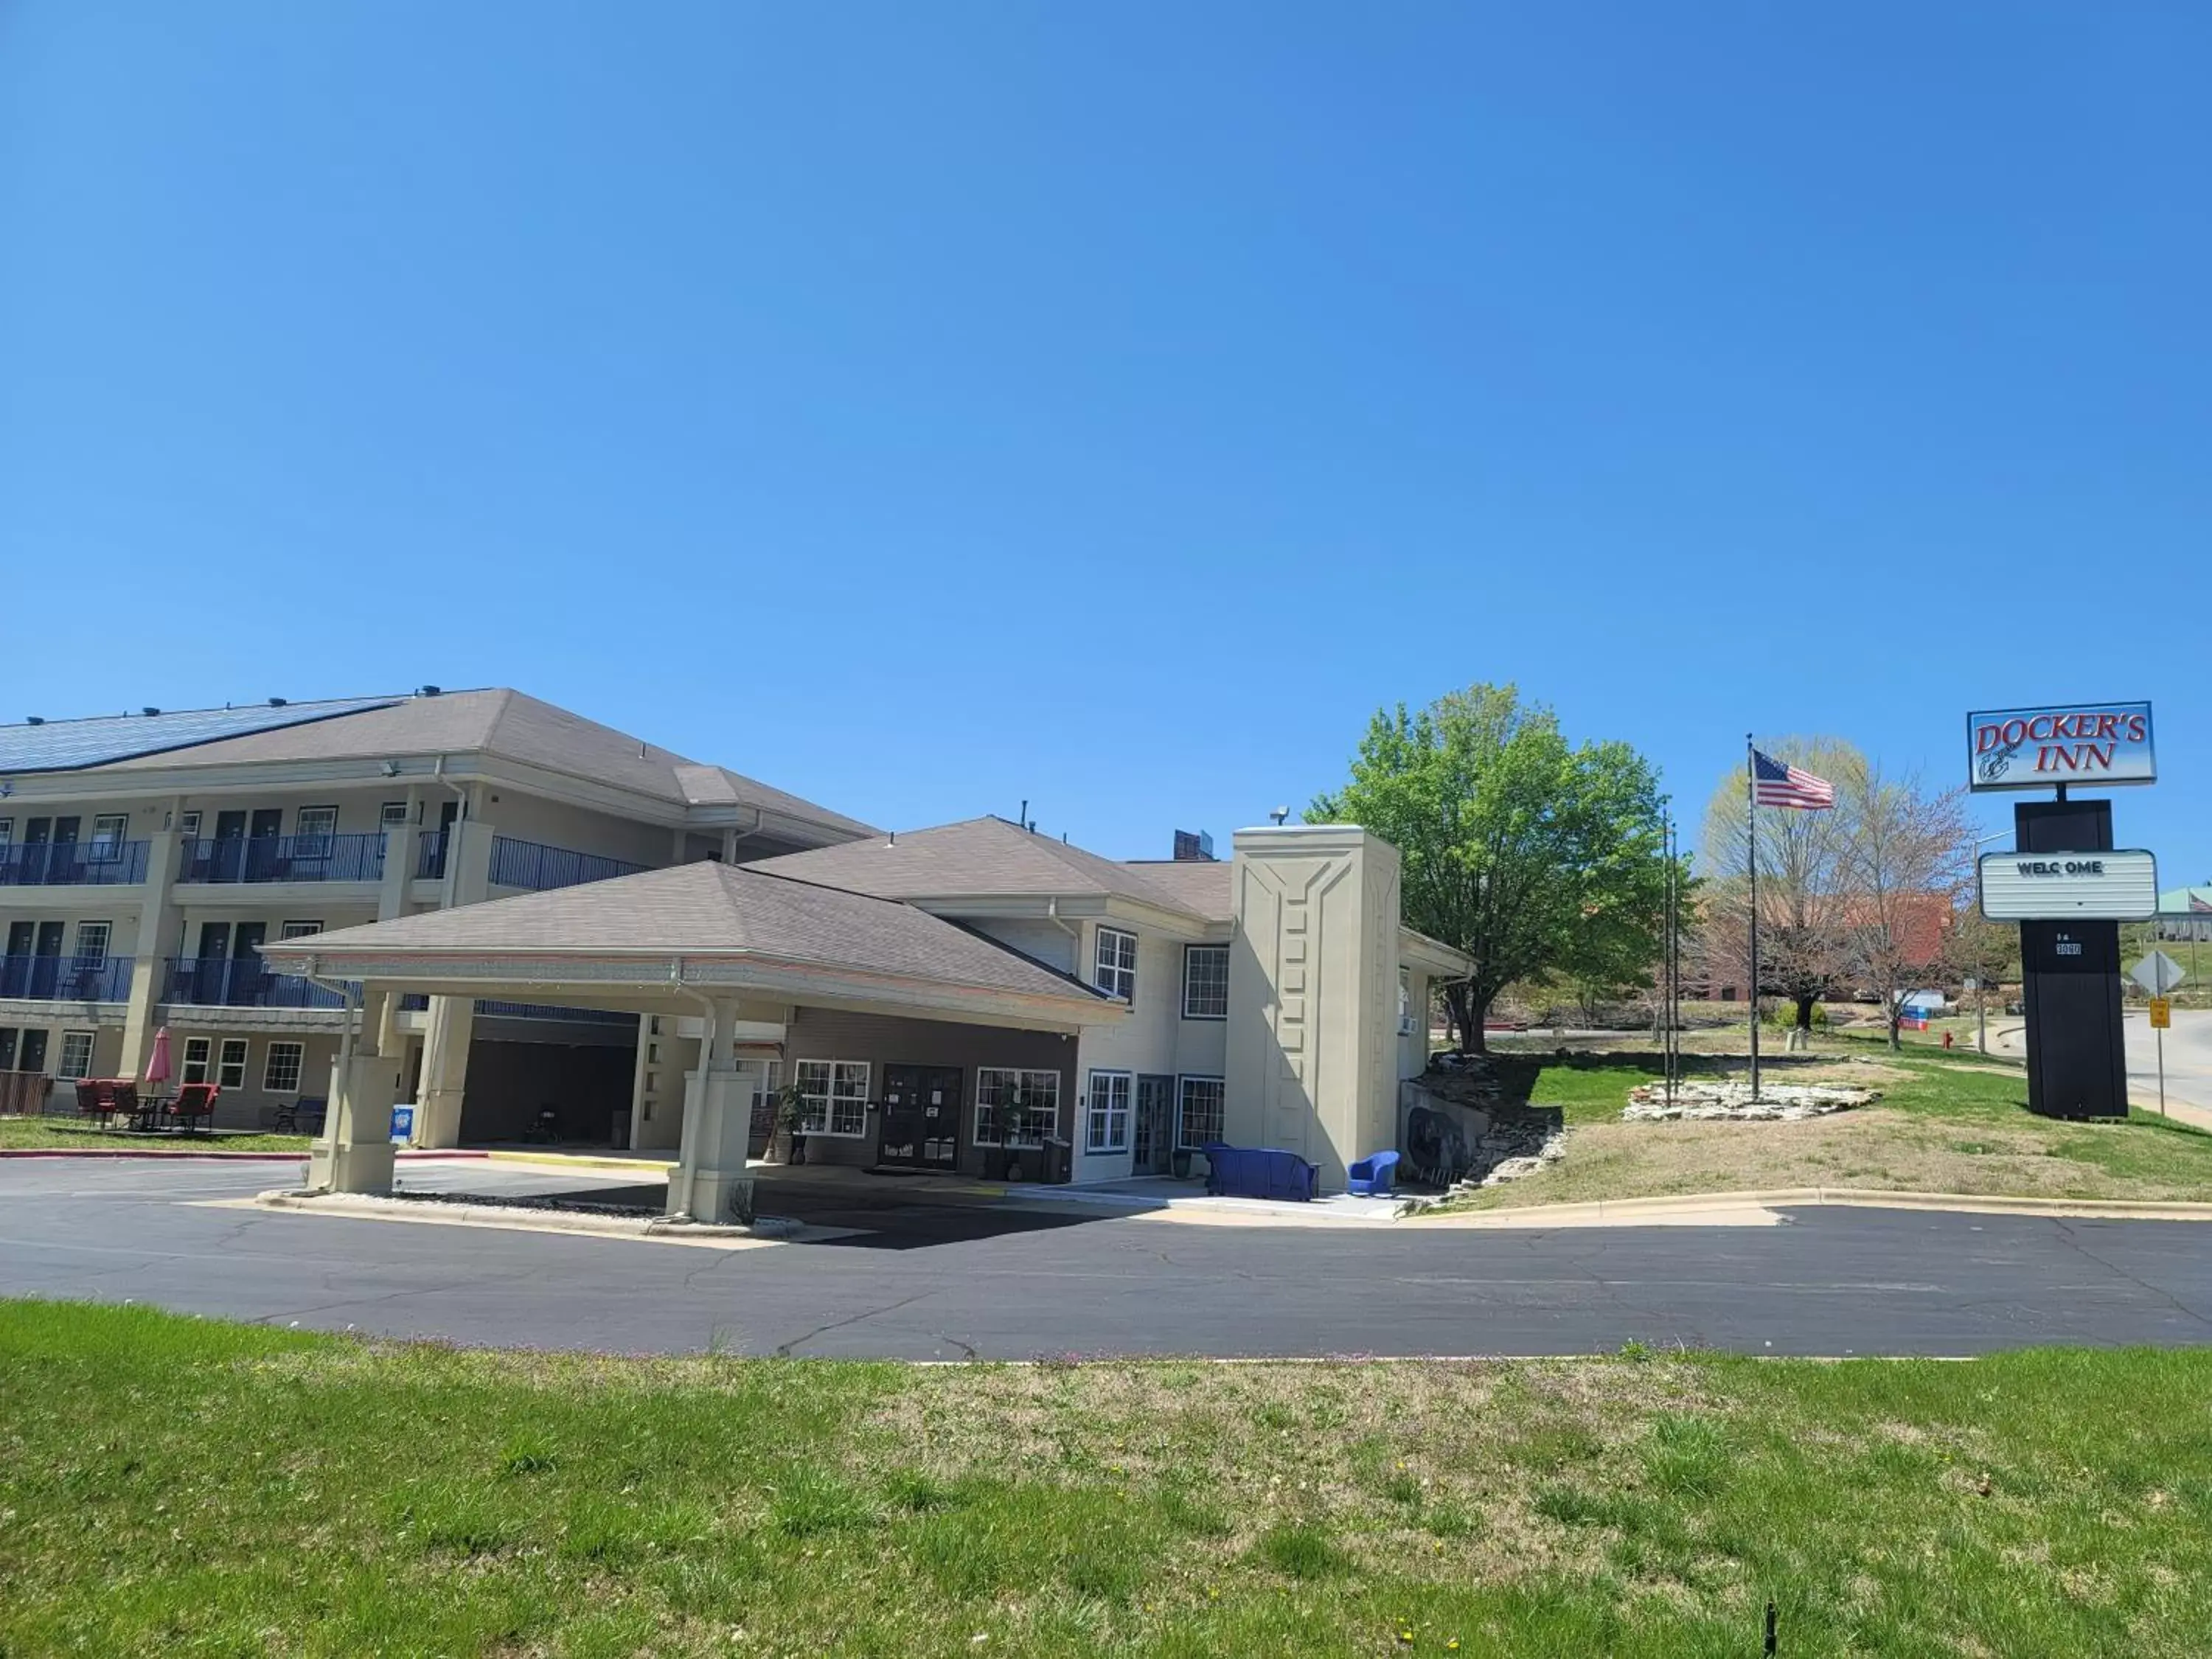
[752,818,1228,920]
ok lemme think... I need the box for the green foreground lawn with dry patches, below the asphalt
[0,1303,2212,1659]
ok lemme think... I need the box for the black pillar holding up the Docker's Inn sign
[2013,801,2128,1117]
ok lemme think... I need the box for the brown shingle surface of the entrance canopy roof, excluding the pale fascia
[265,863,1106,1004]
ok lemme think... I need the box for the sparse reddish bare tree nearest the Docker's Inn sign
[1838,765,1973,1048]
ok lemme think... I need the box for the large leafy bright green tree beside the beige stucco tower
[1305,686,1666,1053]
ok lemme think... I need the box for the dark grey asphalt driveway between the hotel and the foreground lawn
[0,1159,2212,1358]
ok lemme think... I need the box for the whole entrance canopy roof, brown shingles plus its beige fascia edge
[261,863,1128,1031]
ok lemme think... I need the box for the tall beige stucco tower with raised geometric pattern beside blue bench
[1225,825,1400,1190]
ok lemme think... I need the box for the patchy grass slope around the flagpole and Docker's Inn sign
[1449,1053,2212,1210]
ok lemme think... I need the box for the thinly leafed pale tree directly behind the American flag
[1699,737,1867,1035]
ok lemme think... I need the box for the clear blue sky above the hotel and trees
[0,0,2212,883]
